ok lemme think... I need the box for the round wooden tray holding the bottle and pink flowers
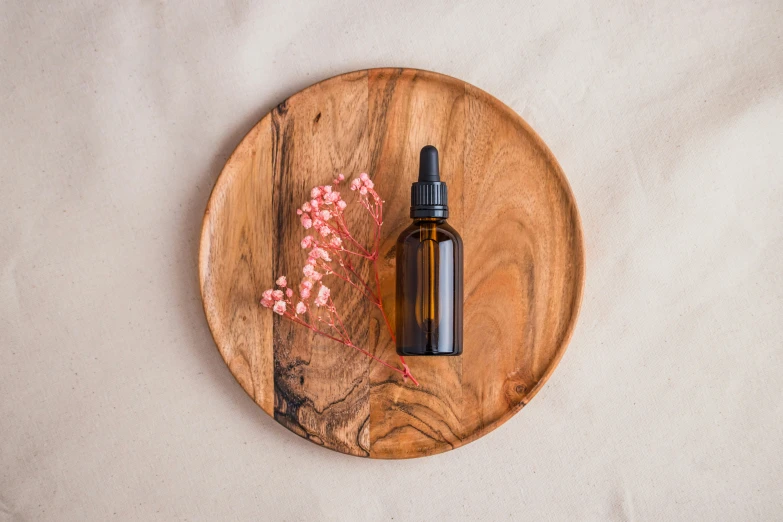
[199,69,584,458]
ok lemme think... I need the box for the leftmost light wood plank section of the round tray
[199,116,274,415]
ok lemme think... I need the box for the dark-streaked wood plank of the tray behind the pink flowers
[272,73,369,456]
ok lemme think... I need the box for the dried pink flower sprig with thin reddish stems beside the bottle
[261,173,419,386]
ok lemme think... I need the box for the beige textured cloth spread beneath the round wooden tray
[0,0,783,521]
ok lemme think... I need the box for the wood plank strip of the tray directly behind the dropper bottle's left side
[369,69,465,458]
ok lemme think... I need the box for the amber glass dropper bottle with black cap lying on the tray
[396,145,462,355]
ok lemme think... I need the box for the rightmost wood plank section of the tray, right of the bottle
[462,85,584,440]
